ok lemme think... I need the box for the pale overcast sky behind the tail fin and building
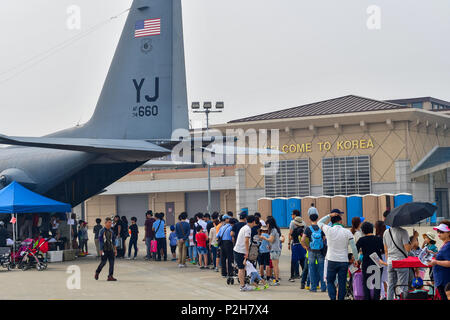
[0,0,450,136]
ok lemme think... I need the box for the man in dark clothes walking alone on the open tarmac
[94,217,117,281]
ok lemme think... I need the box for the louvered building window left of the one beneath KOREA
[264,158,310,198]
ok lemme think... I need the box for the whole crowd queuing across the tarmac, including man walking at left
[88,204,450,300]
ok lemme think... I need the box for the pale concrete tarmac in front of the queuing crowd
[0,227,438,300]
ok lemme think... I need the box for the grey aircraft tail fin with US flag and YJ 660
[52,0,188,139]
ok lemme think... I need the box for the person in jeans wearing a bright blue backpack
[301,213,327,292]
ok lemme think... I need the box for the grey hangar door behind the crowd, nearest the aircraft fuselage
[117,194,148,226]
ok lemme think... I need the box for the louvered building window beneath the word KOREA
[322,156,371,196]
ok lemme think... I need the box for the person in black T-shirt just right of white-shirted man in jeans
[356,222,384,300]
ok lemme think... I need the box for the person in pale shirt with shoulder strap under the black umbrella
[383,227,419,300]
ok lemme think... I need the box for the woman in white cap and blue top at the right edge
[429,220,450,300]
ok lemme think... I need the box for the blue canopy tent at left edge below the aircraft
[0,181,72,249]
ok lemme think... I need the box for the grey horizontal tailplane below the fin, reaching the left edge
[0,135,170,156]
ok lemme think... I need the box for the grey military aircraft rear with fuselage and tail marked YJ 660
[0,0,213,206]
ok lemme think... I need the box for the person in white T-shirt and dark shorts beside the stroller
[233,216,255,291]
